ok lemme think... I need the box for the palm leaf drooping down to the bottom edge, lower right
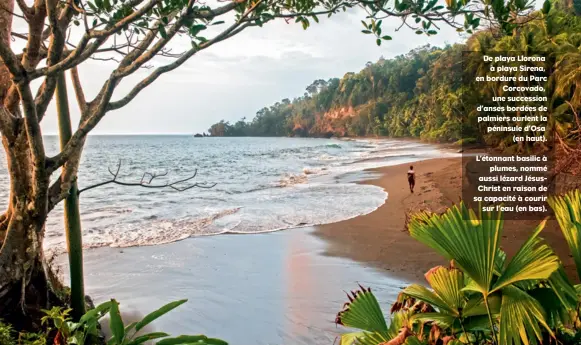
[499,286,553,345]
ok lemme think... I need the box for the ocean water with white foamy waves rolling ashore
[0,136,444,252]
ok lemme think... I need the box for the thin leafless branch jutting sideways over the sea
[79,161,216,194]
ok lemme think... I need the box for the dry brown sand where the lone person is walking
[314,158,576,282]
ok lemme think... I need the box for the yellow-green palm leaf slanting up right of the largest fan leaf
[491,219,560,292]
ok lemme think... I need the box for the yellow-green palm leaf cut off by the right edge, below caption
[549,189,581,279]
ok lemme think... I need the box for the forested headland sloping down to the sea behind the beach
[208,2,581,153]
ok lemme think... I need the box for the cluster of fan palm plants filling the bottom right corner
[336,190,581,345]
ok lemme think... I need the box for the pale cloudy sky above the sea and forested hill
[30,9,465,134]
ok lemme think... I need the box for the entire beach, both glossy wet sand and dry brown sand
[53,149,575,345]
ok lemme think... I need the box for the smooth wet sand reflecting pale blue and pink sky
[60,228,407,345]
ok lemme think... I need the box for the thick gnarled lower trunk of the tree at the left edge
[0,125,62,330]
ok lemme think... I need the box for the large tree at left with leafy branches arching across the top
[0,0,536,331]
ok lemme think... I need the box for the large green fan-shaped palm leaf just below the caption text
[409,202,503,295]
